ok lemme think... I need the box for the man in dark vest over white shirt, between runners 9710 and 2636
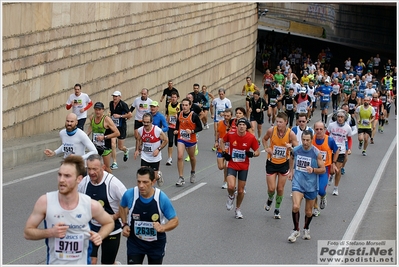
[78,155,126,264]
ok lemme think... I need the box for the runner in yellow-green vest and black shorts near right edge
[355,96,375,156]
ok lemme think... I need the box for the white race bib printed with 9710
[54,234,84,261]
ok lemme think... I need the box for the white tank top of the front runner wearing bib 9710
[44,191,92,265]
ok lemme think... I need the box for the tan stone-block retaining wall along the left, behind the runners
[3,3,257,140]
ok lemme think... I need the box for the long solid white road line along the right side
[329,135,396,265]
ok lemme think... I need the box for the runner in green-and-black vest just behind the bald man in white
[87,102,120,173]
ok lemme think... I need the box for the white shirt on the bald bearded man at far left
[54,128,97,159]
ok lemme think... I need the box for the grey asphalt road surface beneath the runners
[2,98,397,265]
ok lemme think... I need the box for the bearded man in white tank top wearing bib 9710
[24,155,114,265]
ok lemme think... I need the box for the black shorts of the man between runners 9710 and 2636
[90,233,121,264]
